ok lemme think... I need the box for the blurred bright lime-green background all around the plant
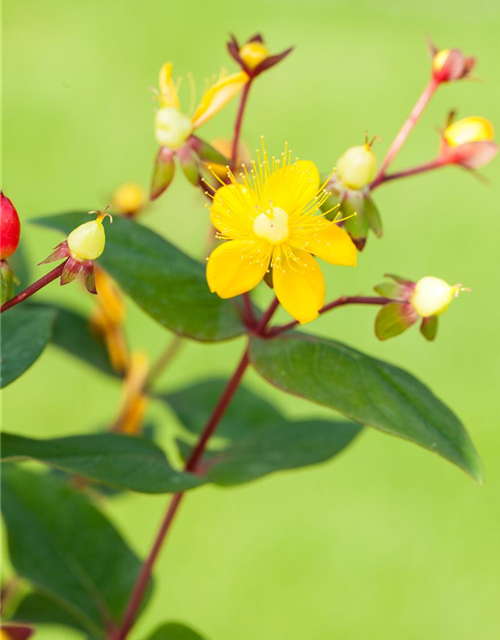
[3,0,500,640]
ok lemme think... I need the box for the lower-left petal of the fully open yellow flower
[207,240,271,298]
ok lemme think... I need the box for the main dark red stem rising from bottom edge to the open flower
[110,300,279,640]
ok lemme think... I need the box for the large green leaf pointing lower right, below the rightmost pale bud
[250,333,482,481]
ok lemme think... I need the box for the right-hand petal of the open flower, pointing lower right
[304,220,358,267]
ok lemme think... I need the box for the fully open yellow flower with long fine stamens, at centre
[207,142,356,323]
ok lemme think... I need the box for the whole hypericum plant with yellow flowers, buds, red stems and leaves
[0,36,497,640]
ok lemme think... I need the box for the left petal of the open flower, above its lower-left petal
[210,184,259,239]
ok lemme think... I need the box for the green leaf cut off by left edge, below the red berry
[0,305,56,388]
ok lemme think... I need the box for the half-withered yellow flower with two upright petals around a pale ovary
[155,62,248,149]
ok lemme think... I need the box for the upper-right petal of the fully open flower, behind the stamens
[261,160,320,216]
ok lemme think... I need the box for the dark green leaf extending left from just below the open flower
[37,213,245,341]
